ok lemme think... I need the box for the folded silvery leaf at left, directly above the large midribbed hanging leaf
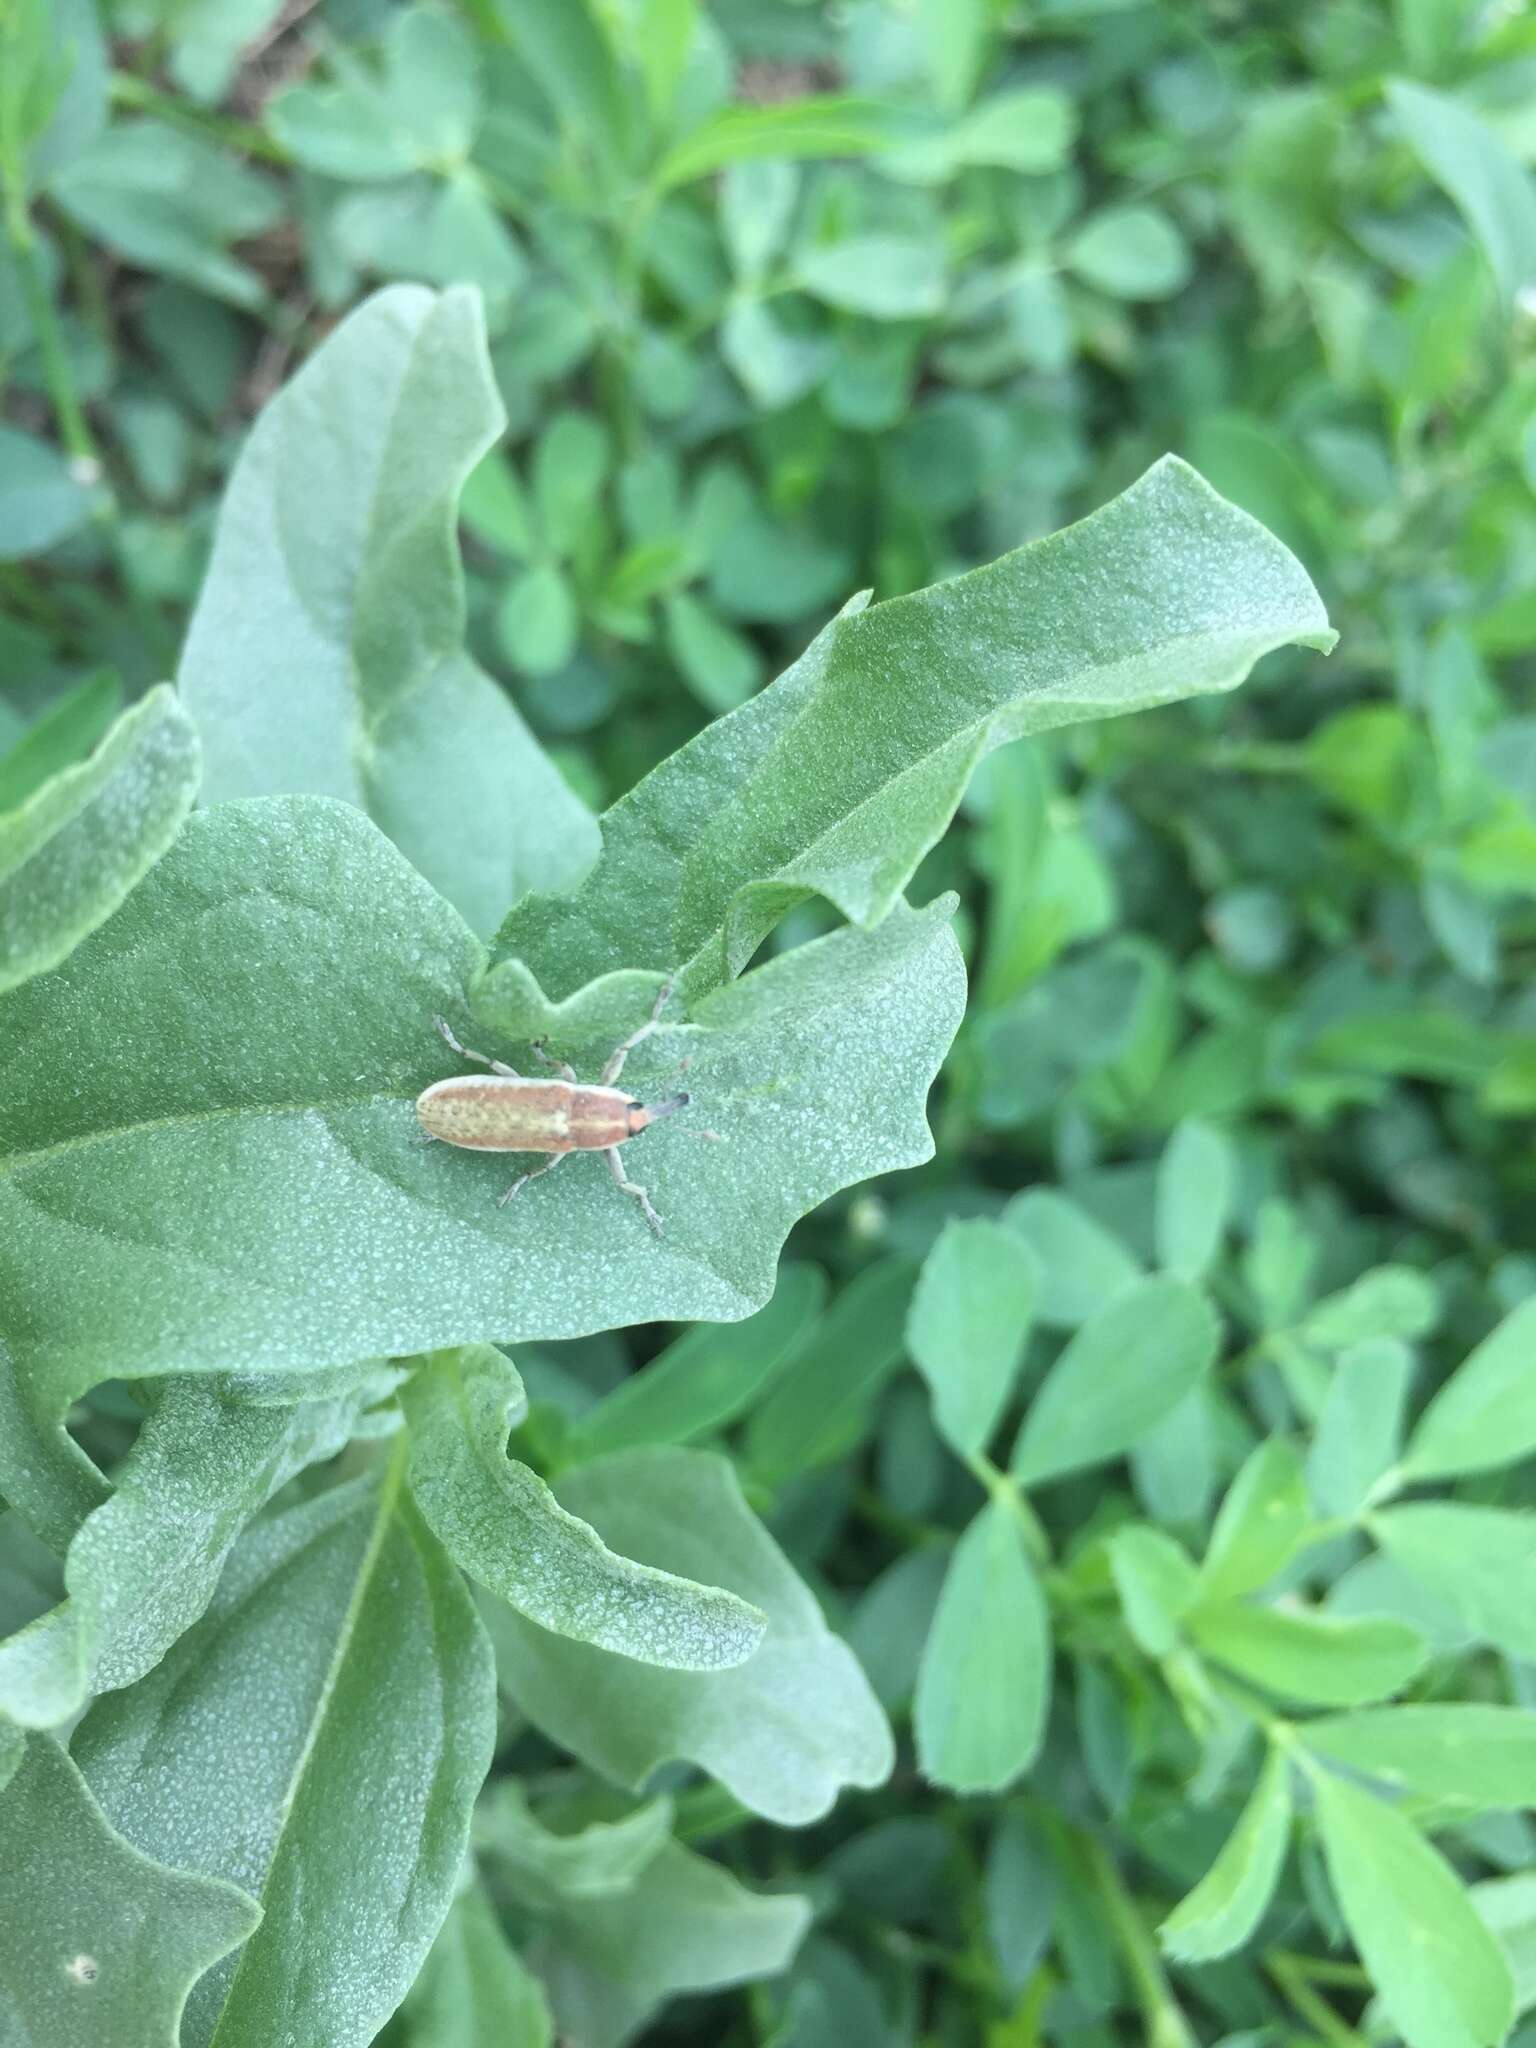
[0,1362,393,1729]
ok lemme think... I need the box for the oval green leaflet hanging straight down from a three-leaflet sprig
[913,1501,1051,1792]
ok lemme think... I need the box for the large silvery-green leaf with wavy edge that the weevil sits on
[0,797,963,1520]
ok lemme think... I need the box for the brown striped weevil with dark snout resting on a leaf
[416,981,692,1237]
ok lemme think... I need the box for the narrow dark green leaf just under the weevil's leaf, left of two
[563,1266,827,1464]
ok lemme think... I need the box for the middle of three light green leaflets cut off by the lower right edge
[1366,1501,1536,1659]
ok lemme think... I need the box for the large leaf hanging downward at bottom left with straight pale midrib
[76,1444,496,2048]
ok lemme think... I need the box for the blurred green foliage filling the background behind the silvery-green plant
[0,0,1536,2048]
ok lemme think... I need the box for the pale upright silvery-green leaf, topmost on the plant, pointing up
[180,285,598,932]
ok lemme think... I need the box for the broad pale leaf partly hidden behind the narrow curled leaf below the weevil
[485,1448,893,1827]
